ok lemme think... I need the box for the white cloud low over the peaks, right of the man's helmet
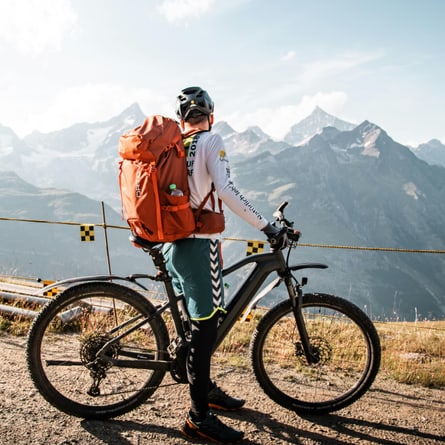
[222,91,348,139]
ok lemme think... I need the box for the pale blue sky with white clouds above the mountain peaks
[0,0,445,145]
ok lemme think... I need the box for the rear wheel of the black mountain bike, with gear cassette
[26,282,168,419]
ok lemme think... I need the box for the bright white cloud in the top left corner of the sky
[0,0,77,55]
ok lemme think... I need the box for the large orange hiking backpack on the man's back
[119,115,196,242]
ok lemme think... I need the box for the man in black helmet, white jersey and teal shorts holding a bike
[164,87,287,443]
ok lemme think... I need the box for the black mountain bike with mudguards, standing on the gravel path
[26,202,381,419]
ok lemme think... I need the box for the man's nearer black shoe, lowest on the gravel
[182,411,244,443]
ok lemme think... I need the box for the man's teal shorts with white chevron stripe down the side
[163,238,225,320]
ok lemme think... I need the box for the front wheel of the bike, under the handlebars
[250,294,381,415]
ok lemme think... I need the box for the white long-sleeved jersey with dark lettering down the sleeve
[184,131,268,238]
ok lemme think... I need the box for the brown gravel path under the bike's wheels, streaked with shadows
[0,335,445,445]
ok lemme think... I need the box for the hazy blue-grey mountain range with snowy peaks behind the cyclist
[0,104,445,319]
